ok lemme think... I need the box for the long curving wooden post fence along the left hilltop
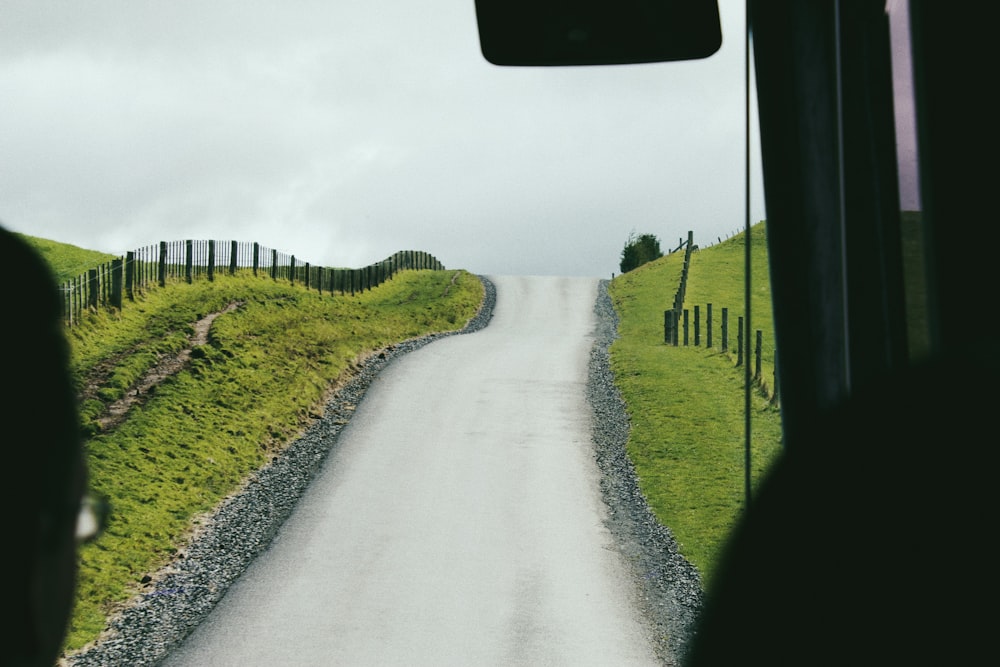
[60,240,444,326]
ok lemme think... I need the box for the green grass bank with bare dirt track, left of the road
[55,264,483,651]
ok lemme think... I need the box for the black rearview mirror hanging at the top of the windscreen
[476,0,722,66]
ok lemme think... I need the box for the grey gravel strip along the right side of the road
[587,280,703,666]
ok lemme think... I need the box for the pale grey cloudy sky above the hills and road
[0,0,764,277]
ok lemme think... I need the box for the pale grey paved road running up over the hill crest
[164,277,659,667]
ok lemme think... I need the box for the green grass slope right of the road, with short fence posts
[610,224,781,589]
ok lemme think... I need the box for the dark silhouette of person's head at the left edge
[0,228,86,667]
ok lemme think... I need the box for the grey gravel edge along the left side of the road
[60,276,496,667]
